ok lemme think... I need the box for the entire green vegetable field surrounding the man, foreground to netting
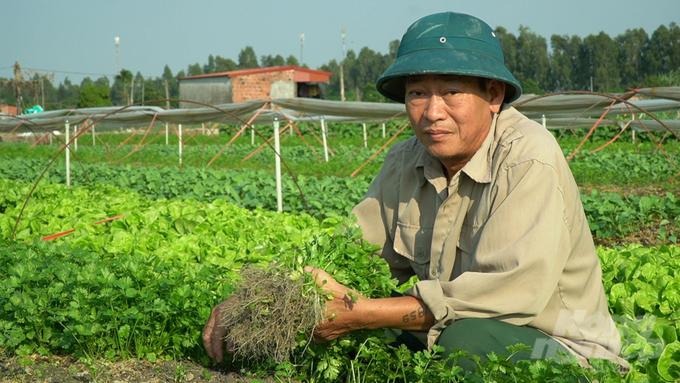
[0,125,680,382]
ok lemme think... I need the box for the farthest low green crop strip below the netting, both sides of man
[2,143,680,189]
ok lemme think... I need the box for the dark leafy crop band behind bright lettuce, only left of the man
[0,157,370,218]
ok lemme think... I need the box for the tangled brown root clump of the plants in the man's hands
[220,265,325,363]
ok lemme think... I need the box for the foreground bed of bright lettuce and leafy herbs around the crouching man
[0,180,680,381]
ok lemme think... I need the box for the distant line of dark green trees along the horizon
[0,23,680,110]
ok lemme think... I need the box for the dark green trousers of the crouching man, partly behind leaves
[395,319,570,371]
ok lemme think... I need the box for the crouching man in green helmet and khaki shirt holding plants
[203,12,628,369]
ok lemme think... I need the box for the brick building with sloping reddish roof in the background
[179,65,331,108]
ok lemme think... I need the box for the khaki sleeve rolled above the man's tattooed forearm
[406,160,570,346]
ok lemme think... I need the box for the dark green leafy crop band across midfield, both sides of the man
[0,157,680,243]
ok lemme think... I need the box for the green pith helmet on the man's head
[376,12,522,103]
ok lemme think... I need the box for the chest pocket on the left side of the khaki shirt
[393,222,432,280]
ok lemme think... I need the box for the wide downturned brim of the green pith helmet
[376,48,522,103]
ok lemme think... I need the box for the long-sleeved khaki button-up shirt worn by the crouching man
[353,105,629,369]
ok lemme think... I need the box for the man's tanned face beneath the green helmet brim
[405,75,505,171]
